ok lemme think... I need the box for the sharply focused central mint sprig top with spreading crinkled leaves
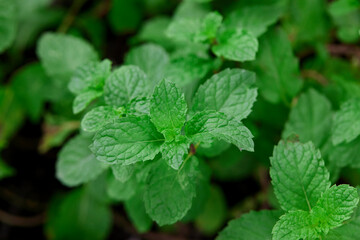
[91,69,256,169]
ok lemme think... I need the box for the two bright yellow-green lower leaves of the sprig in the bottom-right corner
[273,185,359,240]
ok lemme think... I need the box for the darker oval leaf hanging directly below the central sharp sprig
[144,158,199,226]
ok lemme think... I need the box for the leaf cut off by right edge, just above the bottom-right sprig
[332,98,360,145]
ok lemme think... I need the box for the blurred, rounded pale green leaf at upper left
[37,33,98,85]
